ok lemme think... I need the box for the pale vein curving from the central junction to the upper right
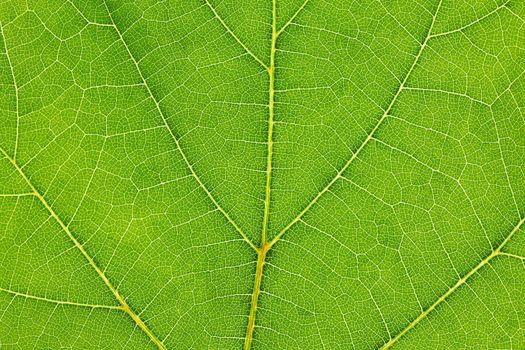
[268,0,442,252]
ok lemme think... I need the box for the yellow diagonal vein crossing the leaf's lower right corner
[380,212,525,350]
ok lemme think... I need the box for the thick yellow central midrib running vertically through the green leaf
[244,0,278,350]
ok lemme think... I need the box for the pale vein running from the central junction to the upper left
[104,1,257,251]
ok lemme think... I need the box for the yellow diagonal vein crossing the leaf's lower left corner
[0,148,166,350]
